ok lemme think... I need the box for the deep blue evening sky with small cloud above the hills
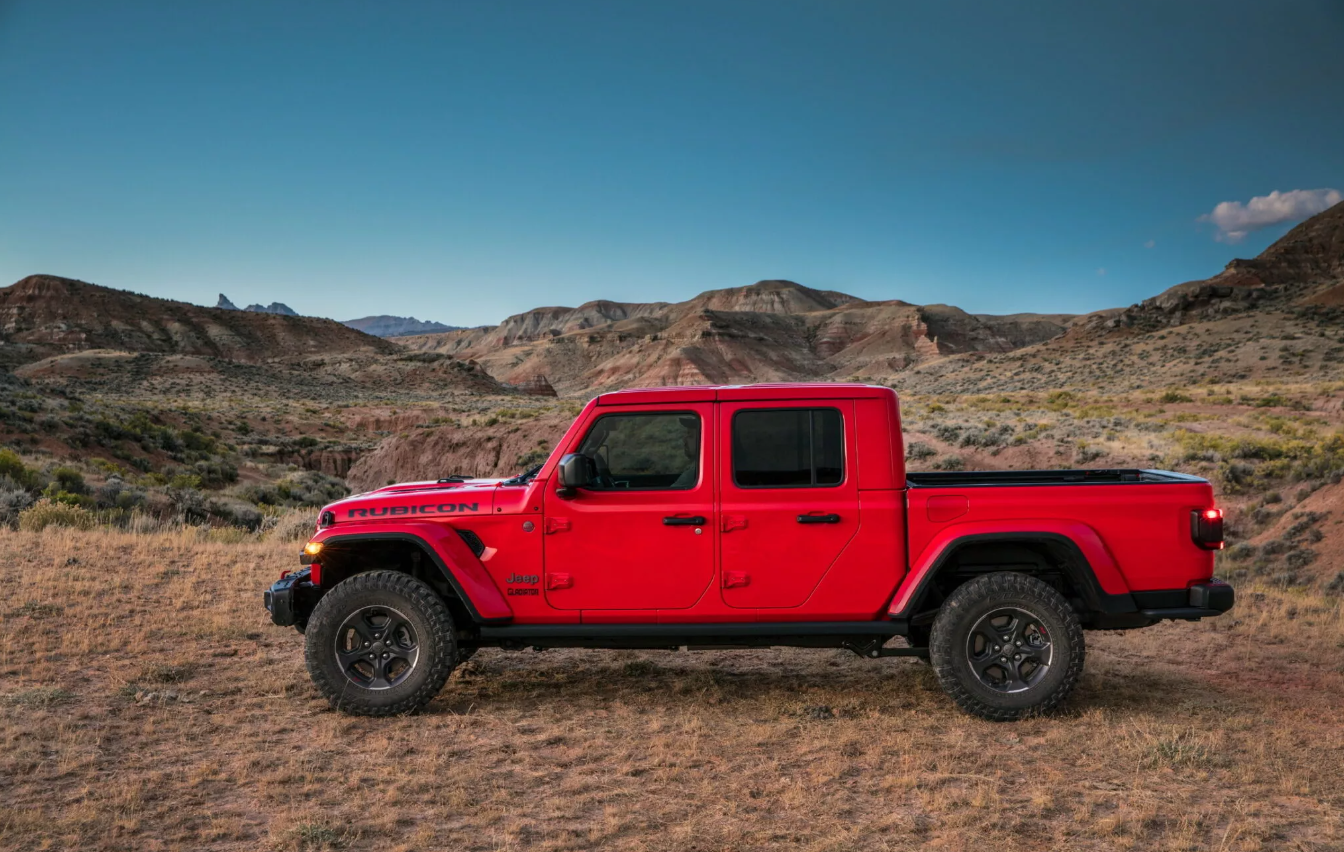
[0,0,1344,325]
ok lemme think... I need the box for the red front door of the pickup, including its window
[544,403,715,610]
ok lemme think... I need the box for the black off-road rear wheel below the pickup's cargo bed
[929,571,1087,722]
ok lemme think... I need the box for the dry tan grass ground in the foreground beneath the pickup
[0,528,1344,852]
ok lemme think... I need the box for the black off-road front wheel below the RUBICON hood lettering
[304,571,458,716]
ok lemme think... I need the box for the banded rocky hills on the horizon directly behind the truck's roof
[399,281,1073,394]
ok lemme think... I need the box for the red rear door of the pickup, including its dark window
[719,400,859,609]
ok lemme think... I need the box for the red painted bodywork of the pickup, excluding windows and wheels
[314,384,1214,624]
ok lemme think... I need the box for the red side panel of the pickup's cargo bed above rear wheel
[909,482,1214,594]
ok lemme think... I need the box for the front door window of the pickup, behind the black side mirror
[579,411,700,491]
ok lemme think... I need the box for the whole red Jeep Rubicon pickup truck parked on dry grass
[265,384,1232,720]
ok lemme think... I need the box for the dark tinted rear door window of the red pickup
[732,409,844,488]
